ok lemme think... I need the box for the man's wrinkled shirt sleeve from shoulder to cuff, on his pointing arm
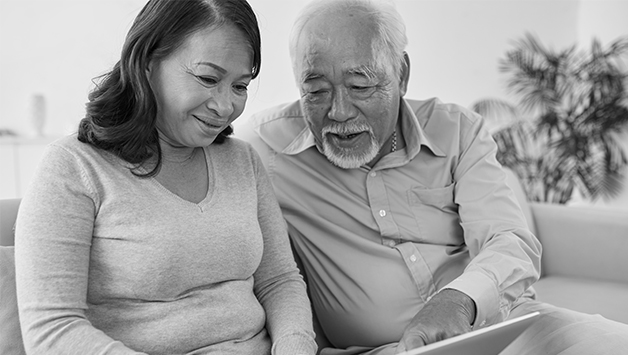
[446,114,541,328]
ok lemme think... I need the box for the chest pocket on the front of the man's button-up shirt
[408,184,464,245]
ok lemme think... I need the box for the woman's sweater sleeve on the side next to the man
[251,150,317,355]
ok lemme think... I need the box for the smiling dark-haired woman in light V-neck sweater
[15,0,316,355]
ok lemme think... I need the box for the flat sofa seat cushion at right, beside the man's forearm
[534,275,628,324]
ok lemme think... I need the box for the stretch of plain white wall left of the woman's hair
[0,0,145,135]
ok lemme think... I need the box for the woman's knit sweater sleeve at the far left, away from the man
[15,145,145,355]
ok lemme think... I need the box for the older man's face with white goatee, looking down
[295,14,405,169]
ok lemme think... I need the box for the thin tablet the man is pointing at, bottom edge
[399,312,539,355]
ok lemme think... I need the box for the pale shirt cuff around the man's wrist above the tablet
[443,271,504,330]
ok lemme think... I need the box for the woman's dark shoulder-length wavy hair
[78,0,261,176]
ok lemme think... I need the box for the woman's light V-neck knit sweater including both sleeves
[15,135,316,355]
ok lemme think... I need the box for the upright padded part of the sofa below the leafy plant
[530,203,628,283]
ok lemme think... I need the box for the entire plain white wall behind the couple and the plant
[0,0,628,205]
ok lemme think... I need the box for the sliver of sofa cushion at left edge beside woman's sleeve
[0,246,26,355]
